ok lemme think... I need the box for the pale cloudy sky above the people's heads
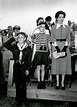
[0,0,77,35]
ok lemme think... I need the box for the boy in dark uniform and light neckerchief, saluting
[3,32,31,104]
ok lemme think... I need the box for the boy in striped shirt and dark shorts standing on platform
[33,22,51,89]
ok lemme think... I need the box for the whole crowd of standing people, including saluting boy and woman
[0,11,74,105]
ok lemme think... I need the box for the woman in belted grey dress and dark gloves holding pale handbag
[51,11,71,90]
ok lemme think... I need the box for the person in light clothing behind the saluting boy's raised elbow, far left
[1,29,12,81]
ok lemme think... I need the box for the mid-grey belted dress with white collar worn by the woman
[51,25,71,75]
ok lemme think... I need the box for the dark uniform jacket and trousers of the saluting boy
[3,37,31,101]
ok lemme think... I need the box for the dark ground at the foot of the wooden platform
[0,83,77,107]
